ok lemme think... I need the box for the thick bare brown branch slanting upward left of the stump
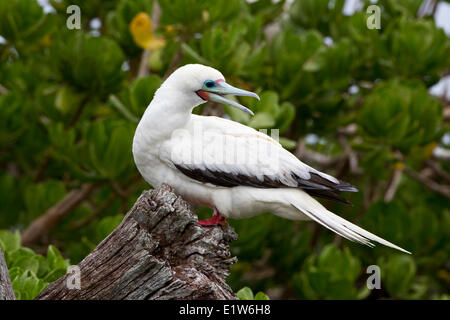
[22,183,95,246]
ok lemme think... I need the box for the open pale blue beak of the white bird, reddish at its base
[197,80,259,116]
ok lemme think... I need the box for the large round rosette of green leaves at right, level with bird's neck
[360,79,442,152]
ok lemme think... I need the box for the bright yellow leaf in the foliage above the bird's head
[130,12,166,50]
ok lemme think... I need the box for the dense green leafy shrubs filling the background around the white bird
[0,0,450,299]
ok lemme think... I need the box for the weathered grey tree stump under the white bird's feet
[34,185,237,299]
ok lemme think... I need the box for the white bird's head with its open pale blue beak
[162,64,259,115]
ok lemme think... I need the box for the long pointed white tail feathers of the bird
[291,203,411,254]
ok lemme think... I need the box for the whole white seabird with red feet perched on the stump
[133,64,409,253]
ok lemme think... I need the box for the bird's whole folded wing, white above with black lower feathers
[160,120,357,201]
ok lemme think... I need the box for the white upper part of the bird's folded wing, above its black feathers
[160,115,337,187]
